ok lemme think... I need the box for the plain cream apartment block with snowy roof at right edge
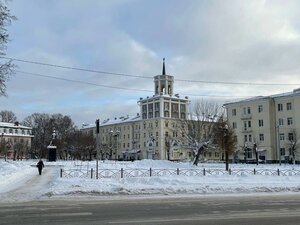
[224,89,300,163]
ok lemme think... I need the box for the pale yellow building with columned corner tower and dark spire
[82,59,192,160]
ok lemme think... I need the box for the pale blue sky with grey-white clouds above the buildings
[0,0,300,126]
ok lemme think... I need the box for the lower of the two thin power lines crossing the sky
[15,70,253,98]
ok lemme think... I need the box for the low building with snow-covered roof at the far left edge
[0,122,34,159]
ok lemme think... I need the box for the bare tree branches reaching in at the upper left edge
[0,1,16,96]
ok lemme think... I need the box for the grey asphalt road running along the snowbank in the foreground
[0,194,300,225]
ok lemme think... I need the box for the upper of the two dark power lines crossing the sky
[0,56,300,86]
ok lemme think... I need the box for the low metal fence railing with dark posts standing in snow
[60,168,300,179]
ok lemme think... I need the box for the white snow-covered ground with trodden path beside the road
[0,160,300,202]
